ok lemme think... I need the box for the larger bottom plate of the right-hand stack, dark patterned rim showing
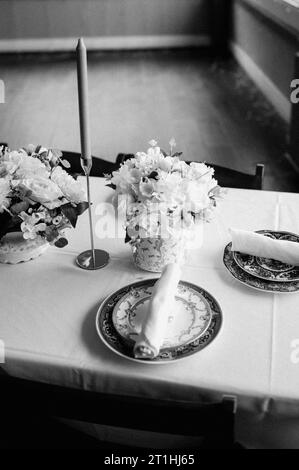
[223,243,299,294]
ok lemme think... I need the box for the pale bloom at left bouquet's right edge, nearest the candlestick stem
[51,166,87,204]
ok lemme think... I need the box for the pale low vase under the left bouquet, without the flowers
[0,232,49,264]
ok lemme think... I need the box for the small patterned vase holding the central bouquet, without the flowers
[132,237,185,273]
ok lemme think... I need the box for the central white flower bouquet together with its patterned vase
[107,139,220,272]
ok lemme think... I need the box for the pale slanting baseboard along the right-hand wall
[231,42,291,122]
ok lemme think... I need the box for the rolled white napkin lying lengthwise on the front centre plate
[134,263,181,359]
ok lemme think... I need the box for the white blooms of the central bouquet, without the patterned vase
[109,139,221,242]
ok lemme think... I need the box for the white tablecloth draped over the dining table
[0,178,299,447]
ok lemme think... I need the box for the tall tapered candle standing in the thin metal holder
[77,38,91,164]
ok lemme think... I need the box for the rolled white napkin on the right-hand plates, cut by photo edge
[230,229,299,266]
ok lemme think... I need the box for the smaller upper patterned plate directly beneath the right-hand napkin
[233,230,299,282]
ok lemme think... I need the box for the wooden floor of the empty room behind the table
[0,51,299,191]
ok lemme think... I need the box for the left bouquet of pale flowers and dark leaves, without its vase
[0,145,88,247]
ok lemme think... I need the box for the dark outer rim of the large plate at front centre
[95,277,223,365]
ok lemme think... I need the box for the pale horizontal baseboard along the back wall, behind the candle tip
[0,35,211,53]
